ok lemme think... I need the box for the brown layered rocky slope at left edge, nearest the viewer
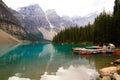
[0,0,29,42]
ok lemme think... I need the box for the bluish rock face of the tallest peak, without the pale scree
[11,4,50,40]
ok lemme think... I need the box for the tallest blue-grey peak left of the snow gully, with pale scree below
[11,4,59,40]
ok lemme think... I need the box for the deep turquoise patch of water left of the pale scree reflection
[0,44,43,65]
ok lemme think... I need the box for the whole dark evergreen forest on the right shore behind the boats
[53,0,120,45]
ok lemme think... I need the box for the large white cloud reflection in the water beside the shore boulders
[40,66,99,80]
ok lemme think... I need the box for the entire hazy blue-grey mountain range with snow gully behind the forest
[11,4,96,40]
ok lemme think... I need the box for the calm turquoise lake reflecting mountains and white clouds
[0,43,120,80]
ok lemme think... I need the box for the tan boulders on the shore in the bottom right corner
[96,59,120,80]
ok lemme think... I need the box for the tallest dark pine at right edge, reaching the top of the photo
[112,0,120,45]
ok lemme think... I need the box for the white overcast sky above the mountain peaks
[3,0,114,17]
